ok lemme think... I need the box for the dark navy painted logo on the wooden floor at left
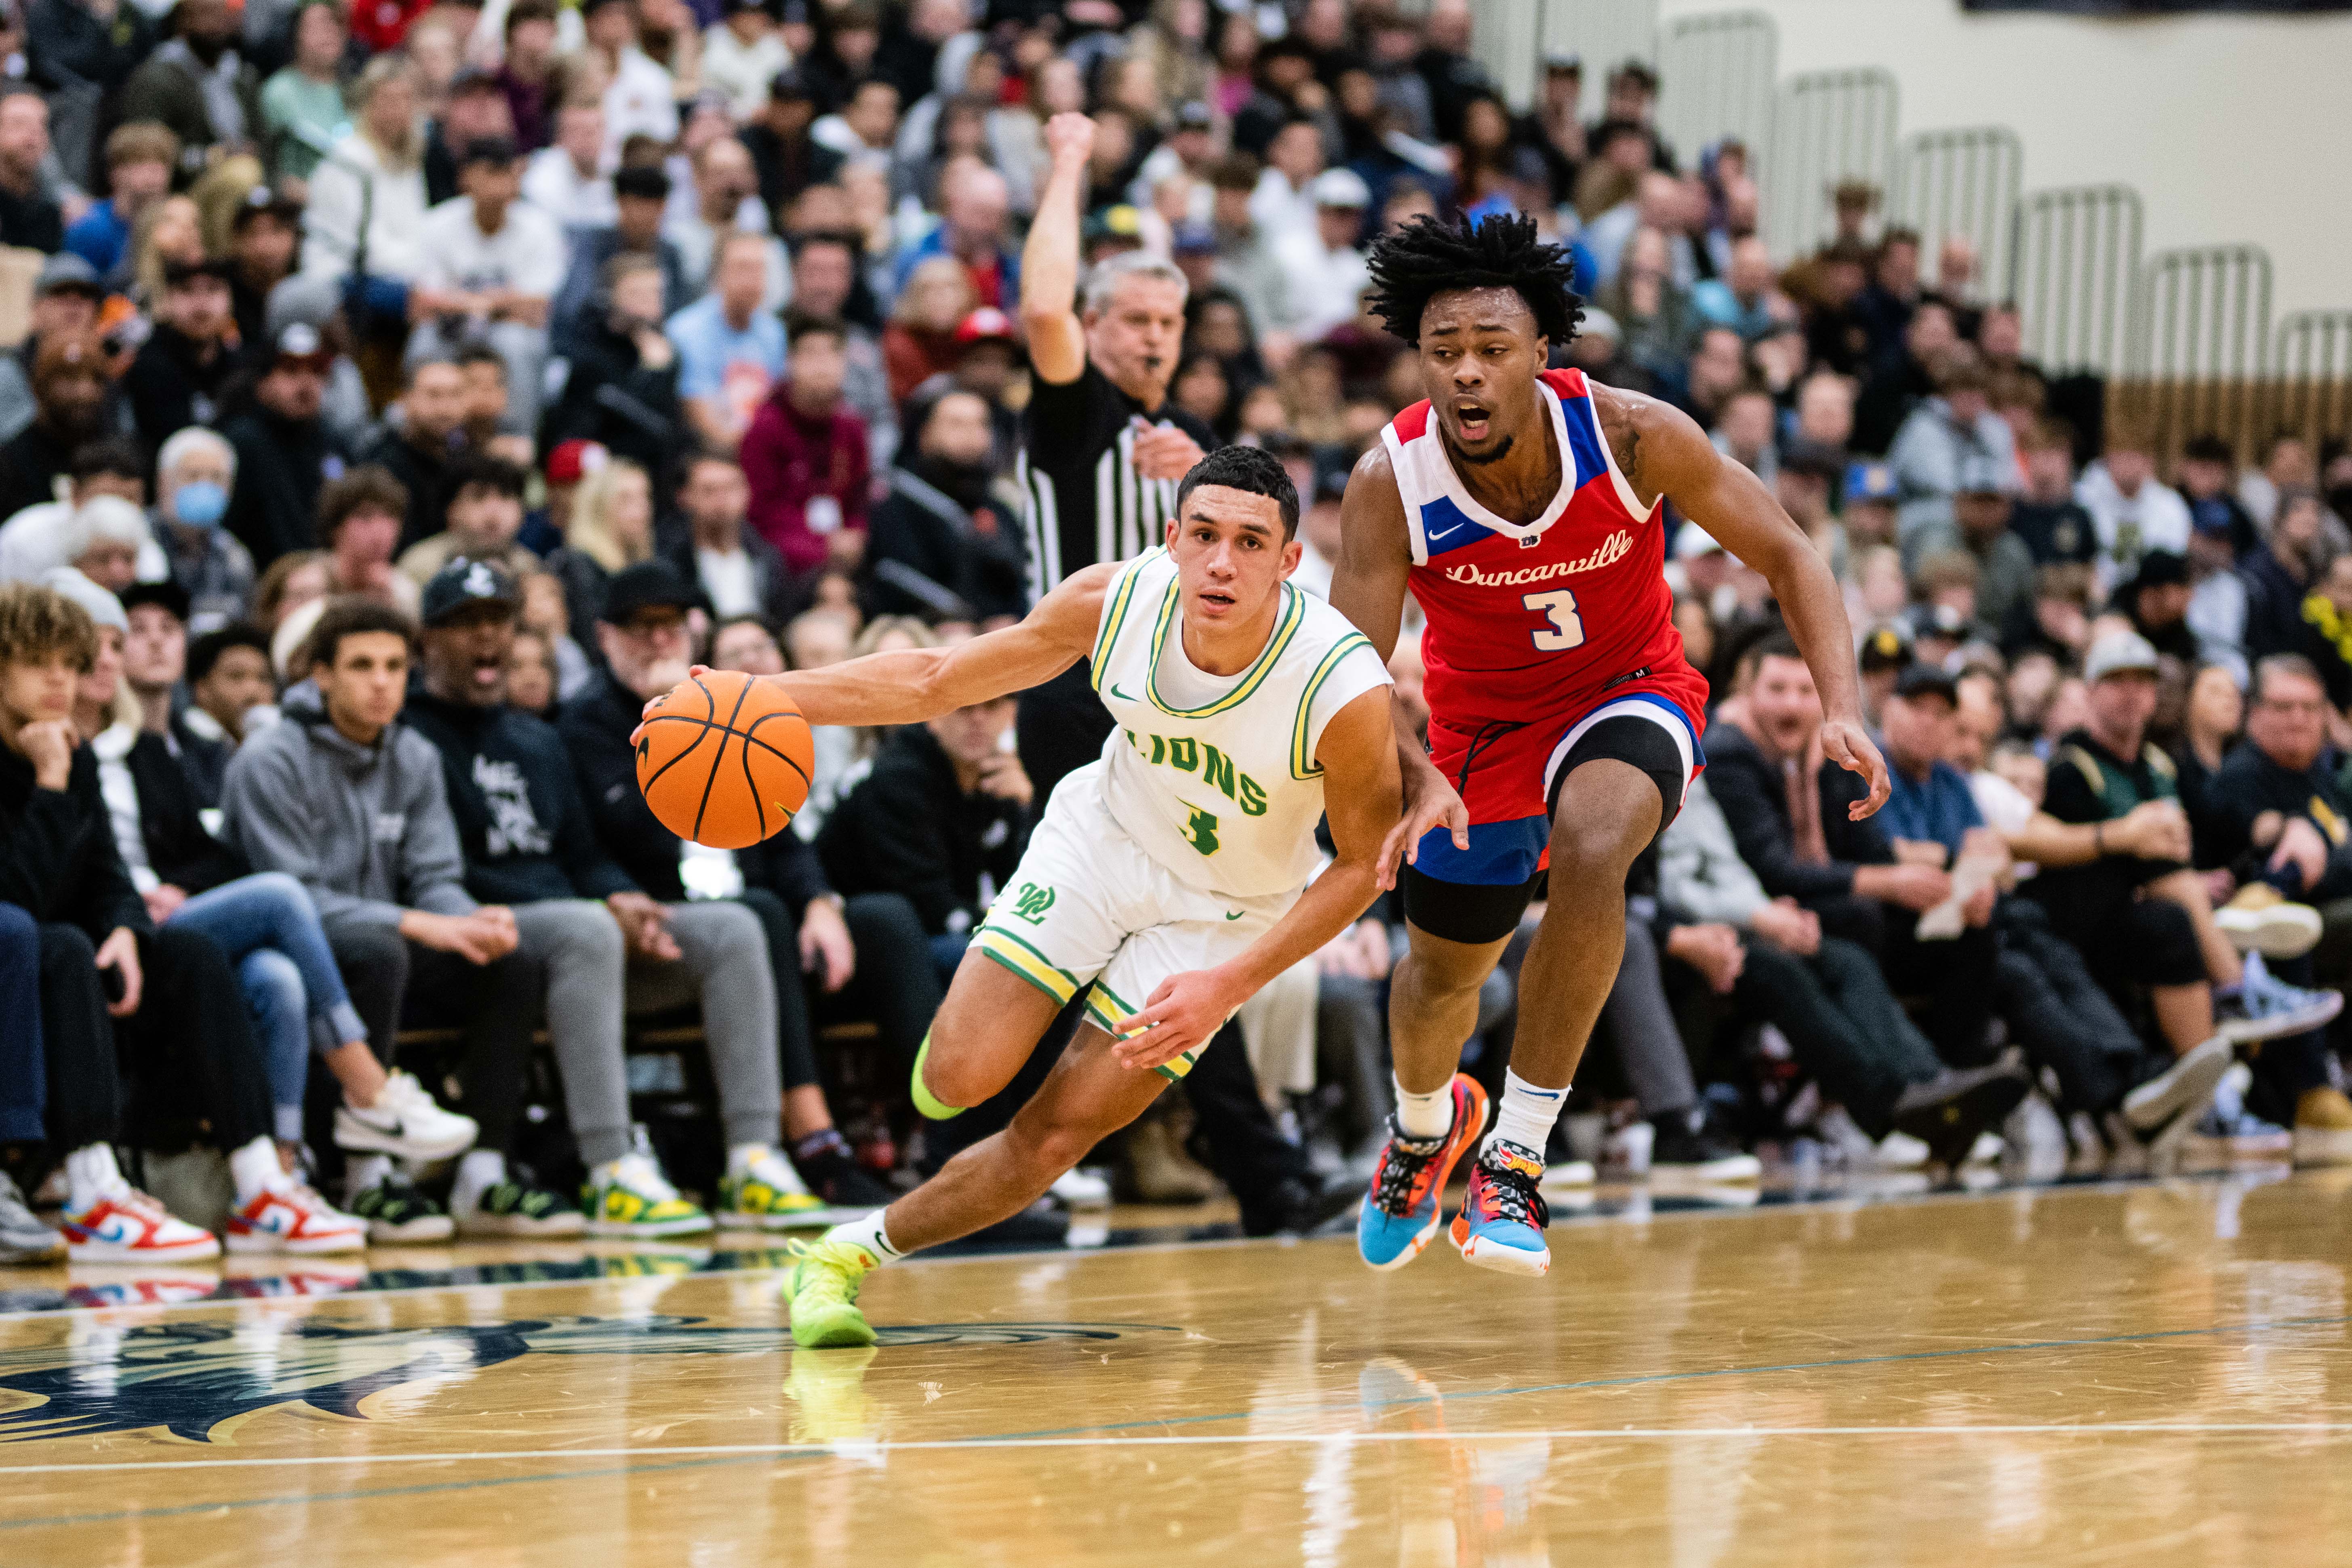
[0,1316,1181,1444]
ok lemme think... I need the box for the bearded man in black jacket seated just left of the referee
[865,388,1028,623]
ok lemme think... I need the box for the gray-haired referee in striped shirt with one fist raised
[1016,115,1216,799]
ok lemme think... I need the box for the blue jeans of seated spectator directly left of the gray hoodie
[167,872,367,1140]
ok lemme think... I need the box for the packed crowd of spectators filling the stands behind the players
[0,0,2352,1258]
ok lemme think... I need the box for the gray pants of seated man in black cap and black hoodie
[515,898,783,1166]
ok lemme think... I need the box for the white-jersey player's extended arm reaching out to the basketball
[644,562,1120,726]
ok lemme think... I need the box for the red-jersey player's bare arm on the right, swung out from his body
[1609,393,1893,821]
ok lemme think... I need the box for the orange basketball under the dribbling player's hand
[637,670,816,849]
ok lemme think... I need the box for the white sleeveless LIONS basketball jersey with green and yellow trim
[1094,548,1388,898]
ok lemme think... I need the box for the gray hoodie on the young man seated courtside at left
[221,682,475,928]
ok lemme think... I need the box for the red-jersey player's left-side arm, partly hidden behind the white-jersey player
[1331,447,1470,888]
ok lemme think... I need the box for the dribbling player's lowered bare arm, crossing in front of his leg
[1112,686,1397,1069]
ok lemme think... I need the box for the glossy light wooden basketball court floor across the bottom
[0,1171,2352,1568]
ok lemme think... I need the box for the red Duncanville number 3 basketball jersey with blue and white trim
[1381,369,1708,733]
